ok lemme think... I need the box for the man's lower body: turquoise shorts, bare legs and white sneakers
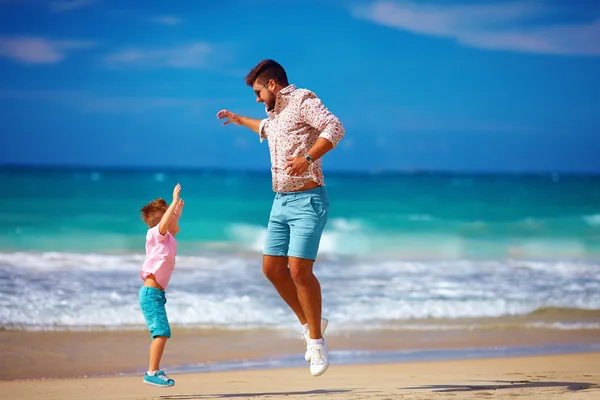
[263,187,329,376]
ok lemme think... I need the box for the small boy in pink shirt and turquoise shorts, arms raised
[139,184,183,387]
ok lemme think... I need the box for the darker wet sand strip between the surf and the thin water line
[0,328,600,380]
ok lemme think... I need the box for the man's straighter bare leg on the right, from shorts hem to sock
[289,257,323,339]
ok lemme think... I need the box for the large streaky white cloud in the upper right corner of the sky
[352,1,600,55]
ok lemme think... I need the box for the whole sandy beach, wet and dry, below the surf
[0,328,600,400]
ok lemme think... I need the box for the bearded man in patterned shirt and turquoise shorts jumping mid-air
[217,60,345,376]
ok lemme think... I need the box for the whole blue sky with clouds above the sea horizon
[0,0,600,172]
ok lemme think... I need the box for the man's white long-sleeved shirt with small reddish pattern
[259,85,346,192]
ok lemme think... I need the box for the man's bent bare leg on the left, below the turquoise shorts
[263,254,308,329]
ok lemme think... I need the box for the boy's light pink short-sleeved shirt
[140,225,177,290]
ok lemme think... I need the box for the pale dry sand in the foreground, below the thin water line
[0,353,600,400]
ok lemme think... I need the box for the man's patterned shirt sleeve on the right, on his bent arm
[301,93,346,147]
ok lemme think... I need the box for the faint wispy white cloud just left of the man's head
[106,42,216,68]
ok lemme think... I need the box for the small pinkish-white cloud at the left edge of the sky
[0,36,95,64]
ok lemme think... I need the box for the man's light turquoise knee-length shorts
[264,186,329,261]
